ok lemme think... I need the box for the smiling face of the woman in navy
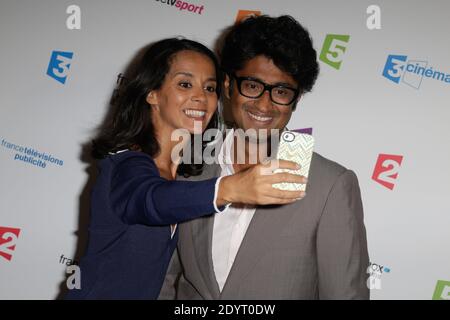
[147,50,217,134]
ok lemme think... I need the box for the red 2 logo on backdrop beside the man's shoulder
[372,154,403,190]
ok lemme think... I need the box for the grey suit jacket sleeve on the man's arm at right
[316,170,369,299]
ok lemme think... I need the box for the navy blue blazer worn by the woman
[65,151,222,299]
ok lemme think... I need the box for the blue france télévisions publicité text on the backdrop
[1,139,64,169]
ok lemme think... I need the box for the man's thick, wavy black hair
[219,15,319,93]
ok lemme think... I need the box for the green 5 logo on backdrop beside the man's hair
[319,34,350,70]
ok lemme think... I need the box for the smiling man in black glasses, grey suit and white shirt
[160,16,369,299]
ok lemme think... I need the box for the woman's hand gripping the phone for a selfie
[217,160,307,206]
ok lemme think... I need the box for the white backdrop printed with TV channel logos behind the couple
[0,0,450,299]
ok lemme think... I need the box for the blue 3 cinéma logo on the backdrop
[383,54,450,89]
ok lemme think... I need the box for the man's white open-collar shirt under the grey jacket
[212,130,256,291]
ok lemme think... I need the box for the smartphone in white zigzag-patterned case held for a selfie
[273,131,314,191]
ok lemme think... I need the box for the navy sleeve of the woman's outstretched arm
[110,155,217,225]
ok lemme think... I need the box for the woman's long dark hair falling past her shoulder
[92,38,222,175]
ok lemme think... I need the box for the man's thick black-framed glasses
[232,75,299,106]
